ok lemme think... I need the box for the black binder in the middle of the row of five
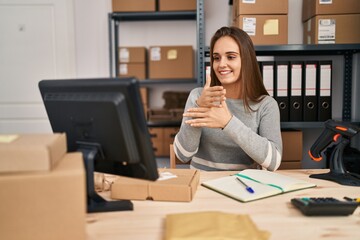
[289,61,304,122]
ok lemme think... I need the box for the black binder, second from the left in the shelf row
[275,61,289,122]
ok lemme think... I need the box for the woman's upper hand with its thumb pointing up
[196,71,226,107]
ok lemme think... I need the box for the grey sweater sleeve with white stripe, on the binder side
[223,97,282,171]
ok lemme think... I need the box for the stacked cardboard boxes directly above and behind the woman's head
[232,0,288,45]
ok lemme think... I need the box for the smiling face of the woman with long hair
[213,36,241,85]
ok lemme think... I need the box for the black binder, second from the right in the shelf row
[303,61,318,122]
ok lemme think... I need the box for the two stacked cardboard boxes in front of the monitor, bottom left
[0,134,86,240]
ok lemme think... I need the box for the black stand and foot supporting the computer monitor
[78,144,134,213]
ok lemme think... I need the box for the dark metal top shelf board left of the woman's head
[110,11,196,21]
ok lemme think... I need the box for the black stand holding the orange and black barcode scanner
[310,137,360,186]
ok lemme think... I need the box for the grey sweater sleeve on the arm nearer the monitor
[174,88,202,162]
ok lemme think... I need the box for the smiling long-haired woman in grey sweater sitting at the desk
[174,27,282,171]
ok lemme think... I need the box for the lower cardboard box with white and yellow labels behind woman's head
[234,15,288,45]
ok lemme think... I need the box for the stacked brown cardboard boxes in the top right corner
[302,0,360,44]
